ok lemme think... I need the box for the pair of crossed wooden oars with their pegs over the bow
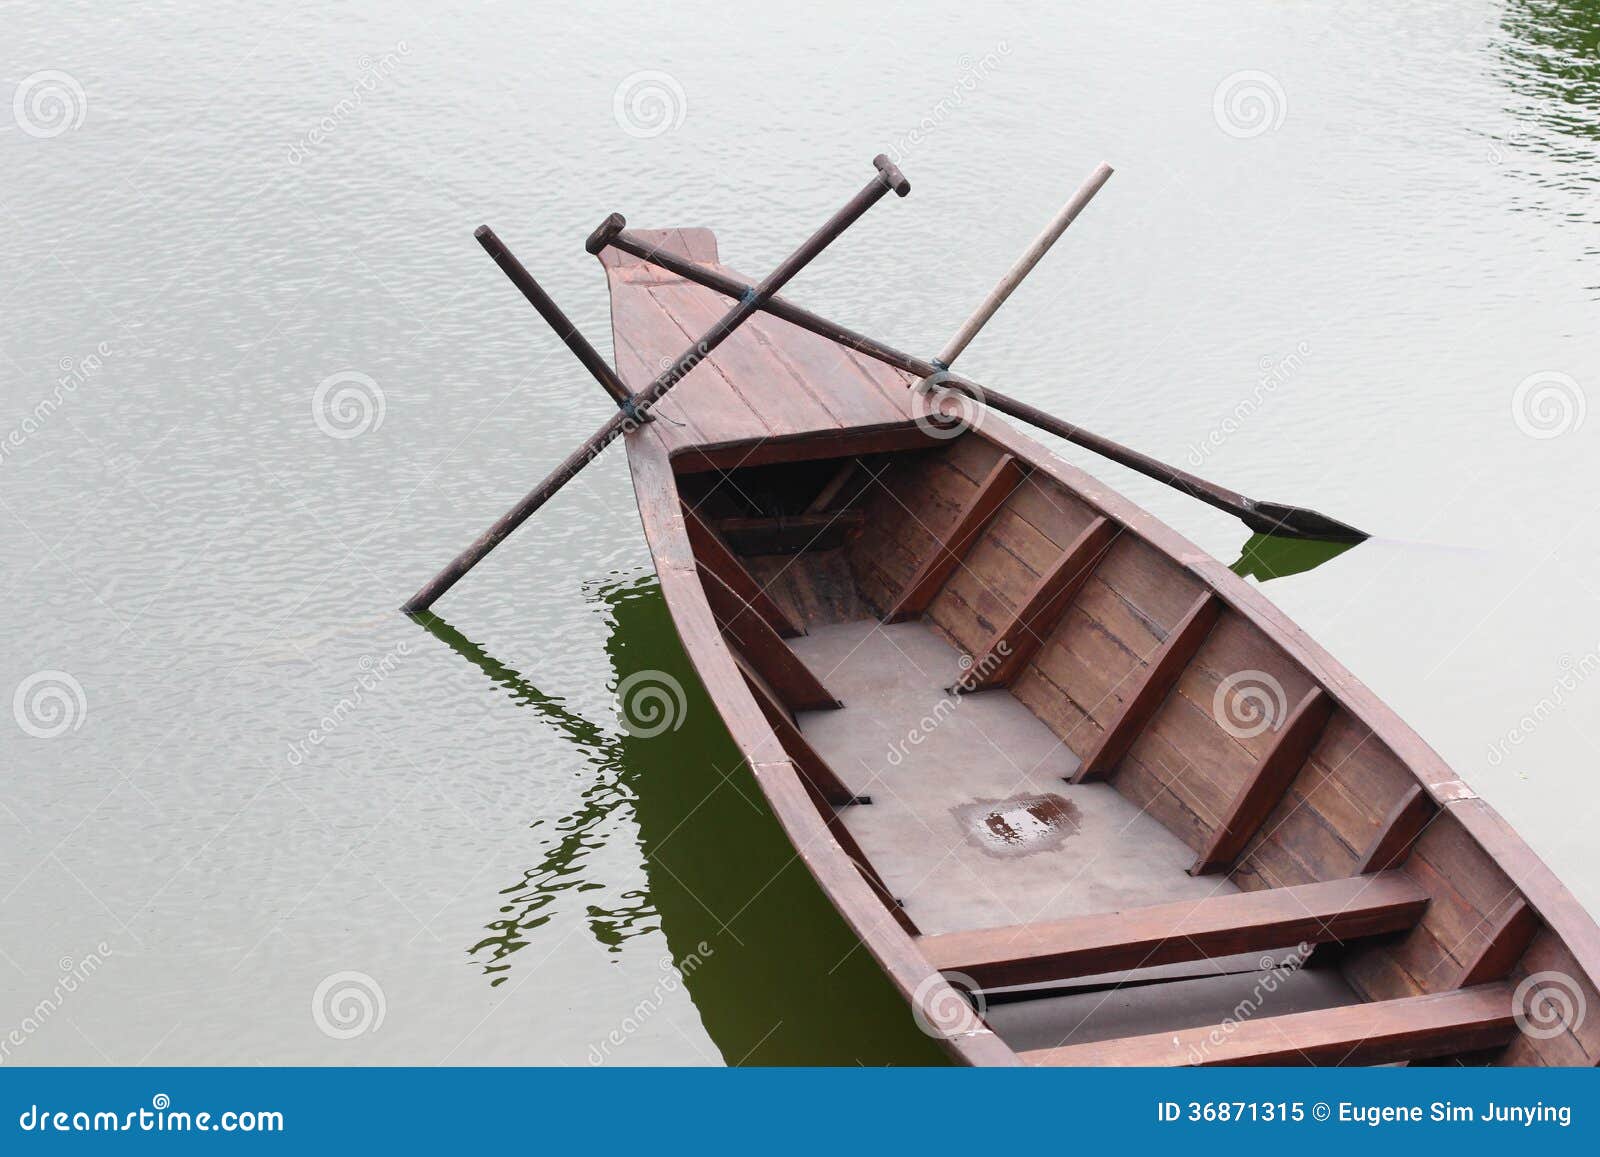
[402,155,1368,615]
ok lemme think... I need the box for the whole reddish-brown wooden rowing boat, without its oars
[602,229,1600,1066]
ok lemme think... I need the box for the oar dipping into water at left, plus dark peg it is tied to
[400,155,910,615]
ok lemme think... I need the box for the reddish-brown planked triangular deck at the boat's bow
[600,229,915,453]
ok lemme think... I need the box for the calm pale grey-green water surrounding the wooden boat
[0,0,1600,1064]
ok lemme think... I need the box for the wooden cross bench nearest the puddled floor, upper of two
[917,874,1429,987]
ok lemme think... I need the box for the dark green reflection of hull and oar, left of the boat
[421,576,946,1064]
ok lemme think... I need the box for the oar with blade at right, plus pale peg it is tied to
[586,165,1368,542]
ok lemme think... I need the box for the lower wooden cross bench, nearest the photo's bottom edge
[1022,984,1517,1066]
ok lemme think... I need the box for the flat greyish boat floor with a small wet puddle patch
[789,619,1237,935]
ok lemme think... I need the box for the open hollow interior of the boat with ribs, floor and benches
[674,430,1600,1064]
